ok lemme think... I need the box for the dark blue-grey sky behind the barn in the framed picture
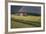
[11,5,41,14]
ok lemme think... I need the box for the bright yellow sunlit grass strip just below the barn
[12,15,40,21]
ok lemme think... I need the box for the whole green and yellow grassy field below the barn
[11,15,41,28]
